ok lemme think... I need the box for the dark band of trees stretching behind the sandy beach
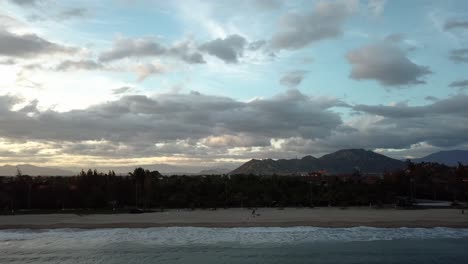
[0,162,468,212]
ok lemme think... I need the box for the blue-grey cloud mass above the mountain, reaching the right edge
[342,95,468,149]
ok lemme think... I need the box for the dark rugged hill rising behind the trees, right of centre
[230,149,405,175]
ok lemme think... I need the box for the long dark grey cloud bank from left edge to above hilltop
[0,90,342,154]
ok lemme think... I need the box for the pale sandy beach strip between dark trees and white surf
[0,208,468,229]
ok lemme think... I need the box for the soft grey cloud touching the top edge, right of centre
[271,0,358,50]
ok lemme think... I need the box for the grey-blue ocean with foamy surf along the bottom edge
[0,227,468,264]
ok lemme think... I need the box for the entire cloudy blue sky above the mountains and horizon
[0,0,468,167]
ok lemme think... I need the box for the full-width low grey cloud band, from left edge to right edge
[0,92,468,159]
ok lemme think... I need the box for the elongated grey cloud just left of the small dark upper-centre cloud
[99,38,205,64]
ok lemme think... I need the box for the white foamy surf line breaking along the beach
[0,227,468,249]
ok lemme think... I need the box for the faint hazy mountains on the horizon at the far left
[0,164,75,176]
